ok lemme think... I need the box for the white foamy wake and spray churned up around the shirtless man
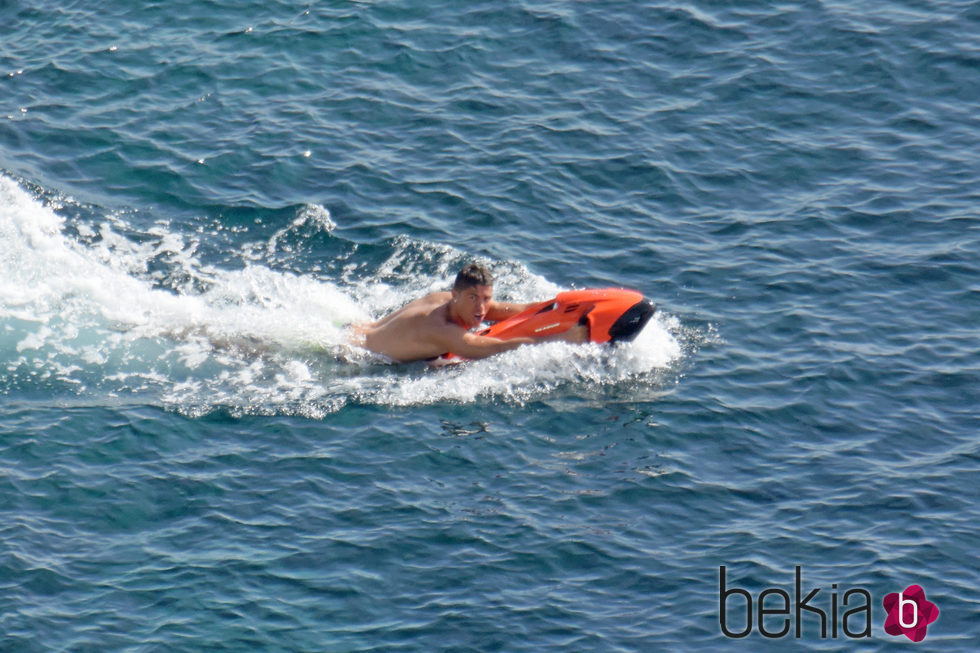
[0,175,685,418]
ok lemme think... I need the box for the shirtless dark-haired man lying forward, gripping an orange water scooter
[355,263,589,363]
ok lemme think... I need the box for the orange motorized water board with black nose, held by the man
[447,288,656,358]
